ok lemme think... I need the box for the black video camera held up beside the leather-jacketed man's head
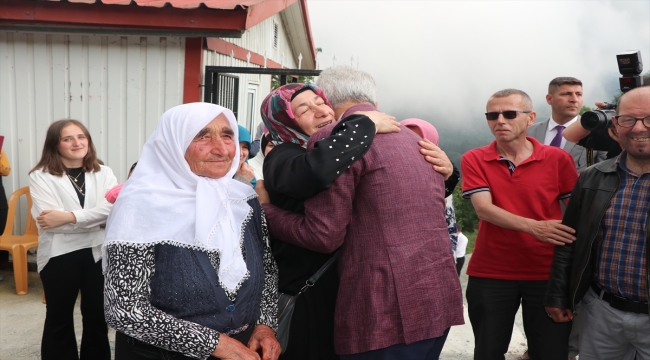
[580,50,643,131]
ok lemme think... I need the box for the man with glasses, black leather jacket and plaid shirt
[544,86,650,360]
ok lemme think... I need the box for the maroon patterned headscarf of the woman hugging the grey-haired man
[260,83,332,146]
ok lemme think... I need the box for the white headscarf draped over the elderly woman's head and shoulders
[104,103,257,293]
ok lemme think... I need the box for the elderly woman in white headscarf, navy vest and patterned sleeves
[103,103,280,360]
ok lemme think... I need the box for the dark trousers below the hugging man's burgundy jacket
[341,329,449,360]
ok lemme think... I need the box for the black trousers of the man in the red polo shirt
[466,276,571,360]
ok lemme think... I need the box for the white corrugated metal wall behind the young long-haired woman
[0,30,185,202]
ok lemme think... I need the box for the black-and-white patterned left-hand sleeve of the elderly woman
[104,243,219,359]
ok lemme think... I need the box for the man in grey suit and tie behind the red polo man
[527,77,606,172]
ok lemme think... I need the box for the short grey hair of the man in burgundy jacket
[316,66,377,108]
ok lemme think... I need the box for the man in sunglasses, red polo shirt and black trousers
[461,89,578,360]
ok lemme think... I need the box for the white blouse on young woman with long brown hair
[29,165,117,272]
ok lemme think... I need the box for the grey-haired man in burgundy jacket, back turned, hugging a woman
[260,67,464,360]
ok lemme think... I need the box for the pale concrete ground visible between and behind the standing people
[0,255,526,360]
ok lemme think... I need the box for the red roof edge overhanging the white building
[0,0,316,64]
